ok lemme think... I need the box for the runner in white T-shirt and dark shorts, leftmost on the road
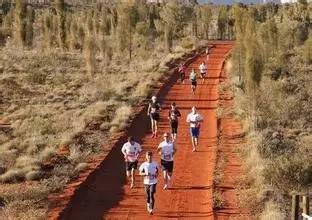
[121,136,142,189]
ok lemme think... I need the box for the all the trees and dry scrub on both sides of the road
[0,0,312,219]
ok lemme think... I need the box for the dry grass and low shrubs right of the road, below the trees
[232,37,312,220]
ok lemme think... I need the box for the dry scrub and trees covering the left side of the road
[0,0,222,219]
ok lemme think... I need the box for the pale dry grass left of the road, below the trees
[0,30,195,219]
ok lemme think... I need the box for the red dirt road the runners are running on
[51,42,246,220]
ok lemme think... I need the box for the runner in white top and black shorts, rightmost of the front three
[157,133,176,189]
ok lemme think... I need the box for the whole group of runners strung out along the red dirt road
[121,46,209,214]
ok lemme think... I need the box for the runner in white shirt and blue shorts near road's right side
[186,106,204,152]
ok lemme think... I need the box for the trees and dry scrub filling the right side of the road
[229,1,312,219]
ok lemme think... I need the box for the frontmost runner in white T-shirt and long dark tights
[139,151,158,215]
